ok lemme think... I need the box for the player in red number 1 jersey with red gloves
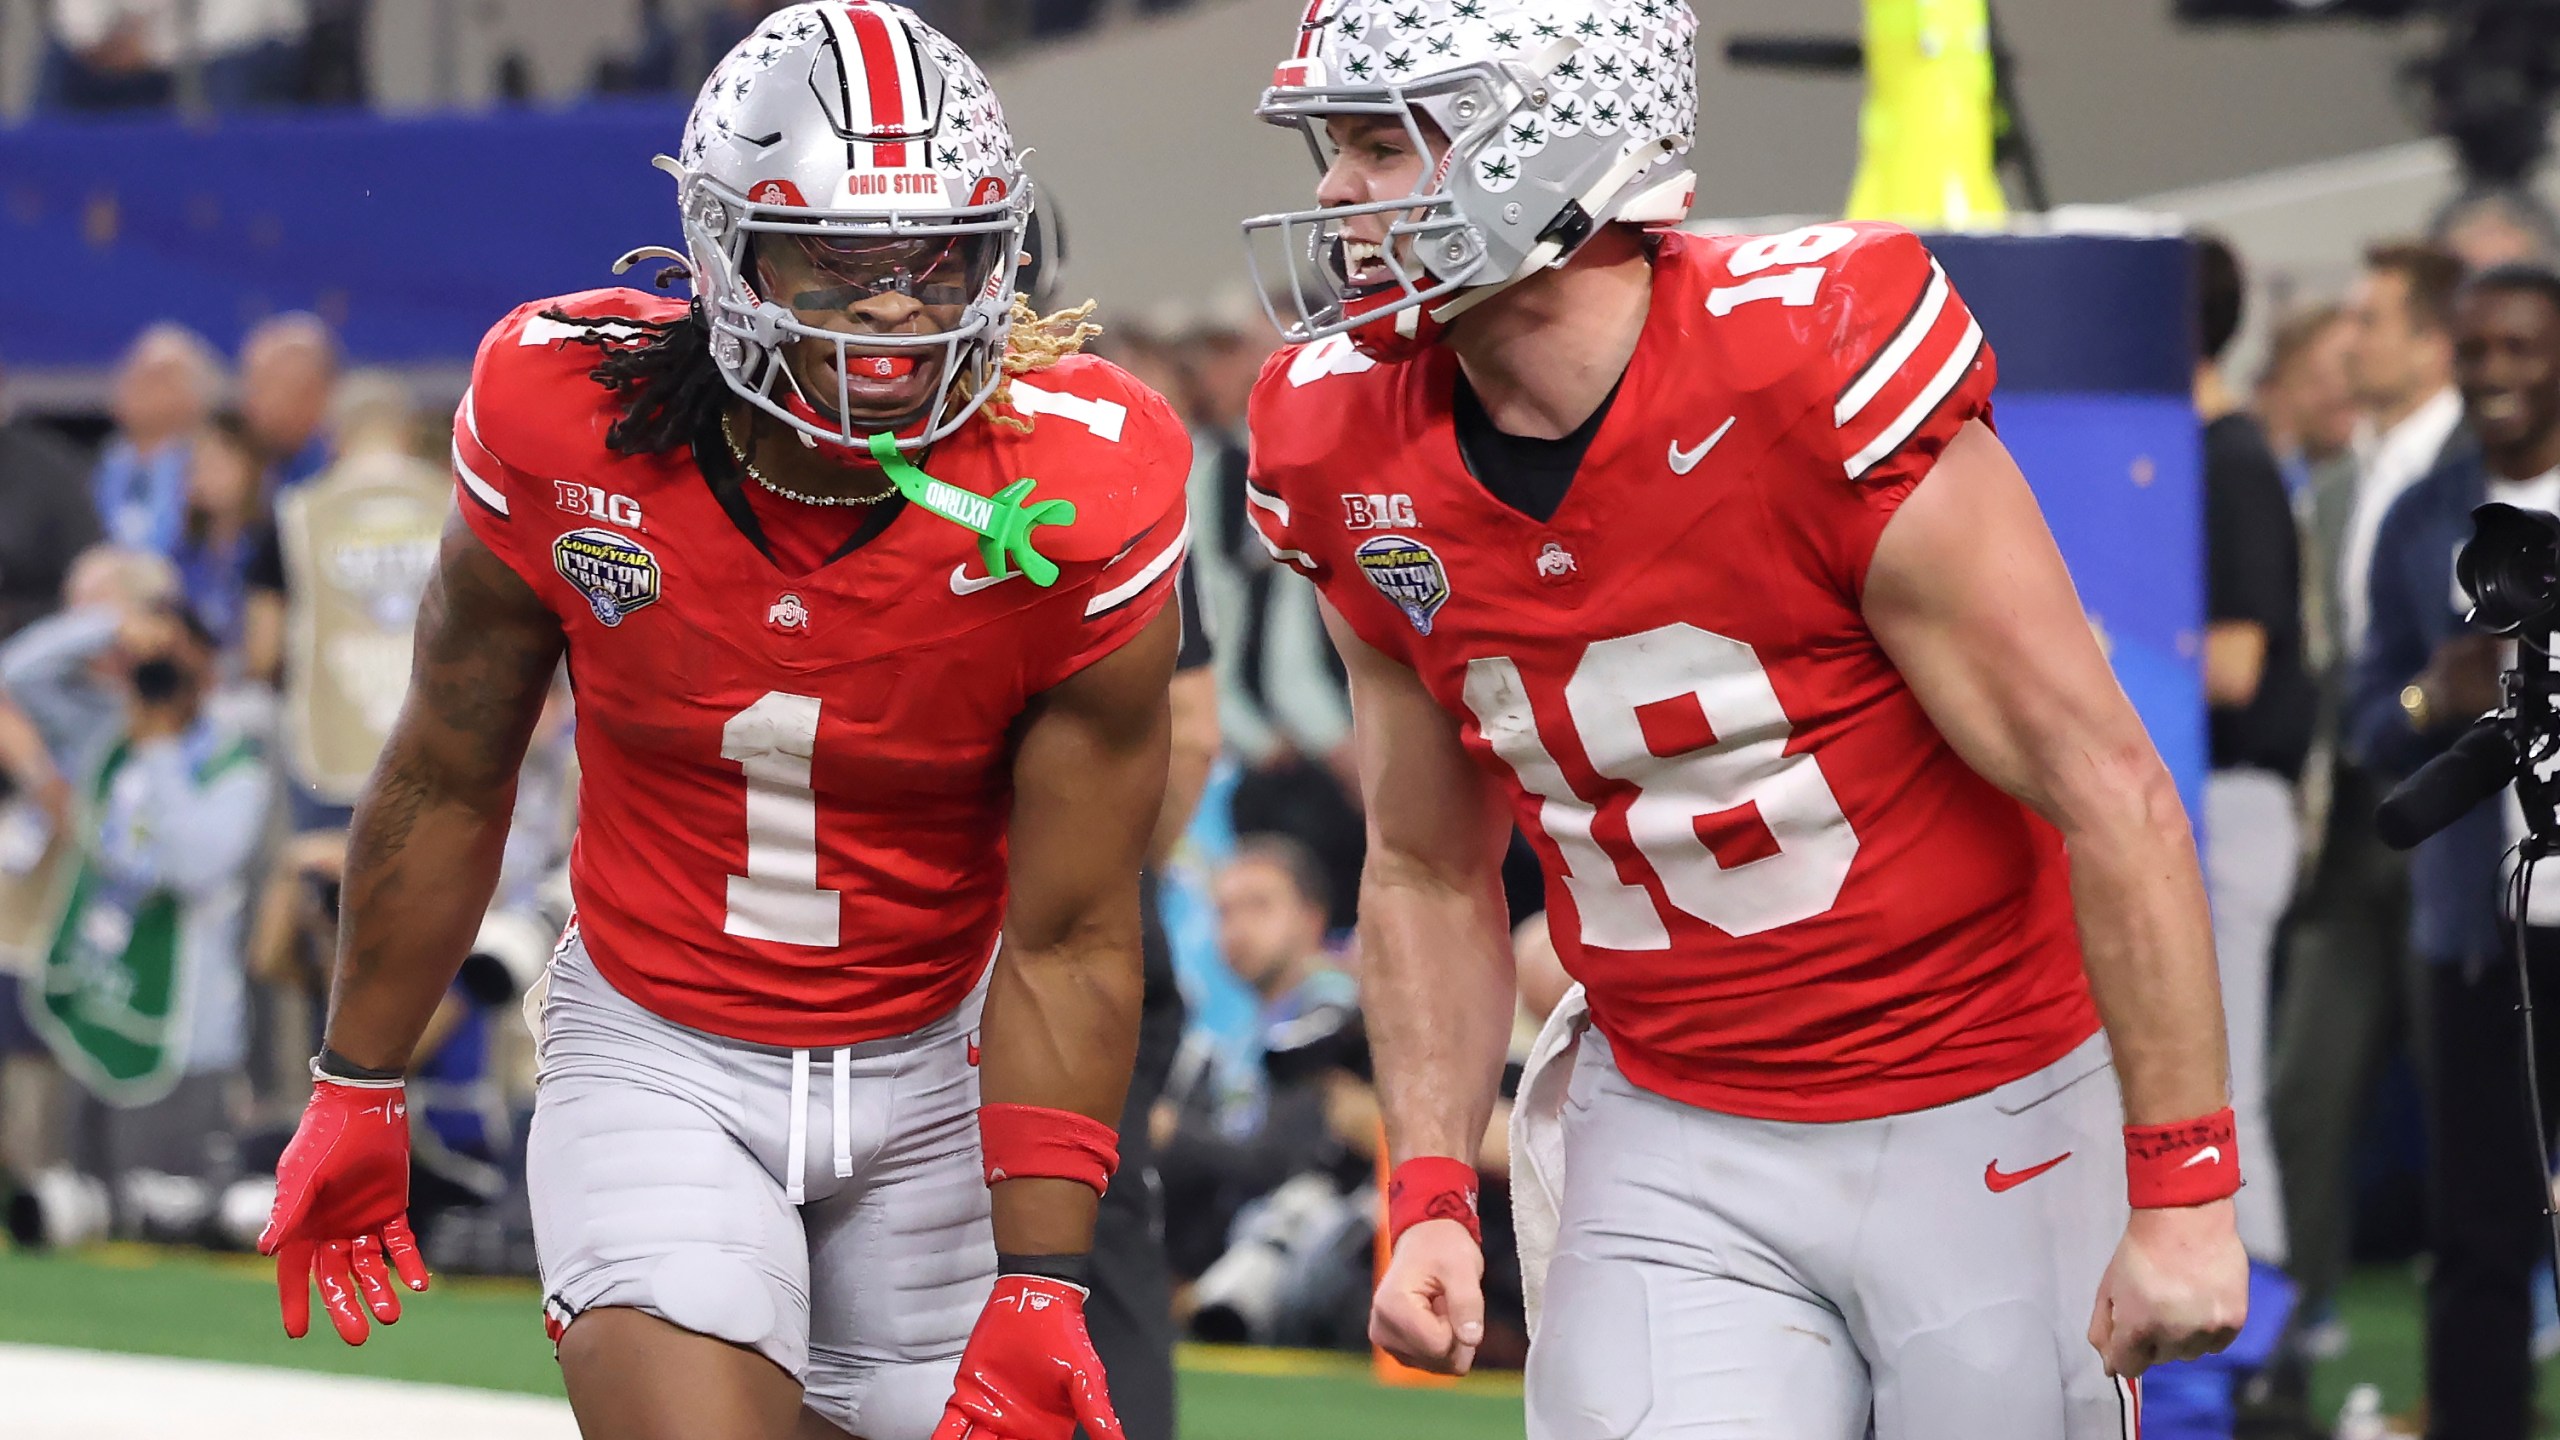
[261,0,1190,1440]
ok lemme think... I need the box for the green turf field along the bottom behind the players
[0,1245,2560,1440]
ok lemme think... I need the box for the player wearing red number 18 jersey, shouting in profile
[1247,0,2245,1440]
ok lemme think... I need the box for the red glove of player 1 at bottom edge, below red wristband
[934,1276,1121,1440]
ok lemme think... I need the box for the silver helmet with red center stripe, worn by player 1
[660,0,1032,451]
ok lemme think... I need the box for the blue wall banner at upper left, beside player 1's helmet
[0,100,684,369]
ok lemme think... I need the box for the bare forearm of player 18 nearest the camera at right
[2063,746,2230,1125]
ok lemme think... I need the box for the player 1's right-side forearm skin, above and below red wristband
[978,917,1147,1256]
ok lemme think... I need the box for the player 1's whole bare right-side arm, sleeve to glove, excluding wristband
[978,607,1180,1256]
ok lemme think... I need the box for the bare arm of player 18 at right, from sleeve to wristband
[1864,423,2230,1125]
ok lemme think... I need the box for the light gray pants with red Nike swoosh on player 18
[1528,1030,2135,1440]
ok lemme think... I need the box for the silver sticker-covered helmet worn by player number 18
[1244,0,1697,356]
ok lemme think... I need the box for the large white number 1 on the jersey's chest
[719,689,845,945]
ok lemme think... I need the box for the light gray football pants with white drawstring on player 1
[525,933,996,1440]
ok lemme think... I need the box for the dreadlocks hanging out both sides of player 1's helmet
[543,295,1103,456]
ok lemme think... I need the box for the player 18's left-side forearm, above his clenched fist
[1359,848,1518,1161]
